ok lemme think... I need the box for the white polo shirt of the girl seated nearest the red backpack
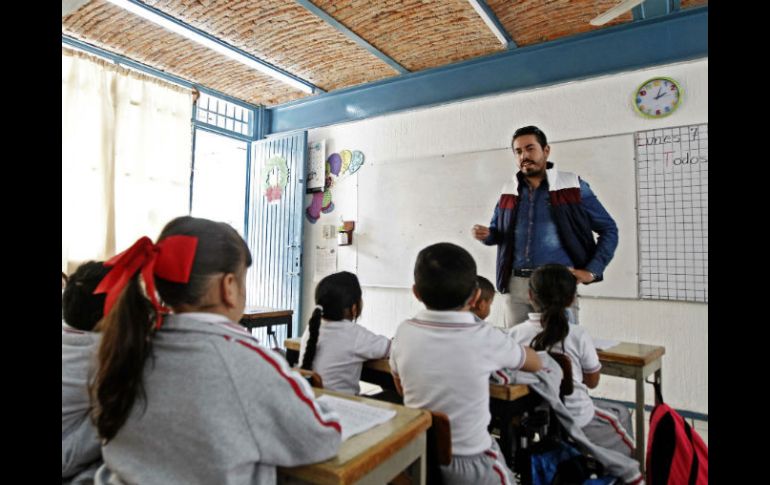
[508,313,602,428]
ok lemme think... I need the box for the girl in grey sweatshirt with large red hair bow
[92,217,340,484]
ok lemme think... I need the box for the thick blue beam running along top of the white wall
[268,6,708,134]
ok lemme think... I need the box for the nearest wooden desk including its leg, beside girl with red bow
[278,389,431,485]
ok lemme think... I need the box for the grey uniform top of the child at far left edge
[61,322,102,483]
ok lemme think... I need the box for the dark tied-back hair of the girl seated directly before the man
[529,264,577,350]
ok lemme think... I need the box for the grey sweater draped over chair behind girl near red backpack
[496,352,644,485]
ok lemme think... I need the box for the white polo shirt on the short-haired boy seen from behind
[390,310,526,455]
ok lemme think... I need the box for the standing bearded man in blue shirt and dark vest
[473,126,618,327]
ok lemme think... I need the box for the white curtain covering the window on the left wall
[62,49,192,273]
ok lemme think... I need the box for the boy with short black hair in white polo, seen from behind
[390,243,542,485]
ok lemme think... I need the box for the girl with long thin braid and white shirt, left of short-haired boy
[299,271,390,394]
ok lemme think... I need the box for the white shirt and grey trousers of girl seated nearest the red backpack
[509,313,634,456]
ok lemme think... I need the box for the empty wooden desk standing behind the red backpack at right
[597,342,666,468]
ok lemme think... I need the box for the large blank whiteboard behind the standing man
[356,134,639,298]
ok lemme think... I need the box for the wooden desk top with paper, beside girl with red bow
[278,389,431,485]
